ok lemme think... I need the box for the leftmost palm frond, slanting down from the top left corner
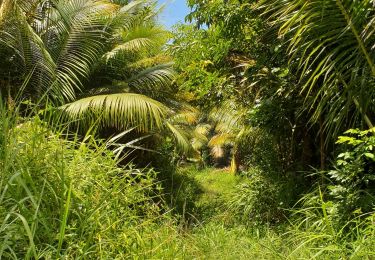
[0,0,59,98]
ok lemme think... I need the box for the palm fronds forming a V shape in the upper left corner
[0,0,118,102]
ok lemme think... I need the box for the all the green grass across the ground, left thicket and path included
[0,107,375,259]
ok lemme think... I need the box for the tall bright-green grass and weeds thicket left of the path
[0,101,176,259]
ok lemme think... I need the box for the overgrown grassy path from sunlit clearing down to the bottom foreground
[164,167,282,259]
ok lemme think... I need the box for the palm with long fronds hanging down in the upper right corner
[260,0,375,136]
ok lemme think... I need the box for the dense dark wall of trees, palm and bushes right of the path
[170,0,375,256]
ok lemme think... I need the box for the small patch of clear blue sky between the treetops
[158,0,189,28]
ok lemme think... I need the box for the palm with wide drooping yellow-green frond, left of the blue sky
[58,1,188,148]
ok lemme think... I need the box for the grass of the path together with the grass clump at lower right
[167,166,375,259]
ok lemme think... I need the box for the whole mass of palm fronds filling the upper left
[0,0,192,152]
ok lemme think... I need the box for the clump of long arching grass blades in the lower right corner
[284,187,375,259]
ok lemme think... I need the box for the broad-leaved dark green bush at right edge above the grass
[328,128,375,221]
